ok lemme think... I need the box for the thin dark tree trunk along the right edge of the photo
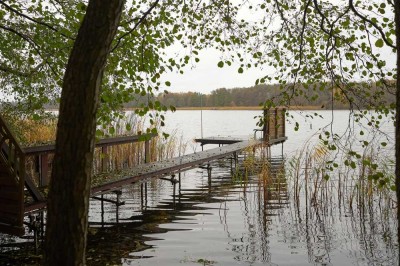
[394,0,400,260]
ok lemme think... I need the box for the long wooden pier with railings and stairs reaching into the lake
[0,109,287,235]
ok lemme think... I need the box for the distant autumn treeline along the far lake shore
[126,81,394,109]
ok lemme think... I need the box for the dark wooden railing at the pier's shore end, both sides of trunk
[0,111,156,235]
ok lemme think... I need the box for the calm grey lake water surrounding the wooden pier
[0,111,399,265]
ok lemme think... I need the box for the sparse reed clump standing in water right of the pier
[287,136,395,217]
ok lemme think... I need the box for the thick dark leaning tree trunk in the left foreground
[45,0,124,266]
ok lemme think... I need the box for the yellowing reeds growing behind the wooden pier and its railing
[7,111,187,188]
